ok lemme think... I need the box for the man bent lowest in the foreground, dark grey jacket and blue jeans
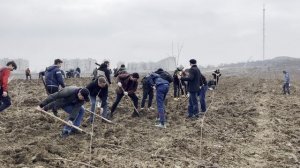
[36,86,90,137]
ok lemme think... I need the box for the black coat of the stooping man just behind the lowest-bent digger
[86,79,108,108]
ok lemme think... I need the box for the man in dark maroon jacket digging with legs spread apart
[111,73,139,118]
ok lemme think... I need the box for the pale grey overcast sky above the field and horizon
[0,0,300,70]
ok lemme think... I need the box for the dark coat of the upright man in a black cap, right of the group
[181,65,201,92]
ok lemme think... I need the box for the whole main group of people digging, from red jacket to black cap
[0,59,223,137]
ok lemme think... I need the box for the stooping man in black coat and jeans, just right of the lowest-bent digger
[86,76,109,123]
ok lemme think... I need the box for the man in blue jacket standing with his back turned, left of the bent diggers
[45,59,65,94]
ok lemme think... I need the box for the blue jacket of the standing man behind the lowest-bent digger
[45,65,65,88]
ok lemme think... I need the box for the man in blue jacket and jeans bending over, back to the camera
[145,73,170,128]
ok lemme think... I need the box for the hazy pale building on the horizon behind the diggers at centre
[127,57,176,73]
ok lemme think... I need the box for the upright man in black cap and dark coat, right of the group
[178,59,201,118]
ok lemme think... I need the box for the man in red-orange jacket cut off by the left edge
[0,61,17,112]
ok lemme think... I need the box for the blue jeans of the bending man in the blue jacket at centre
[156,84,169,125]
